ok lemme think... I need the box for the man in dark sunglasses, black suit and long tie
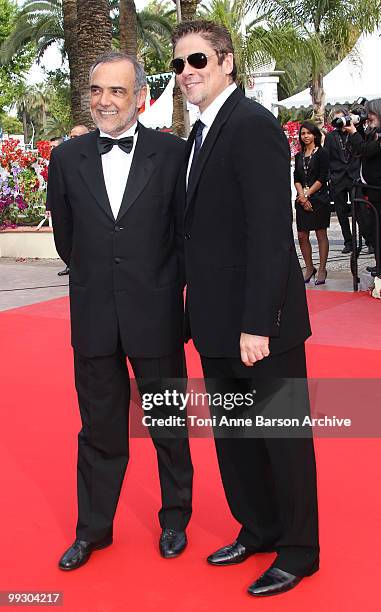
[172,20,319,596]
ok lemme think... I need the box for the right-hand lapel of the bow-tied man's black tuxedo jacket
[117,124,155,221]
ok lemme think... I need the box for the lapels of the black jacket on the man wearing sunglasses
[185,88,244,212]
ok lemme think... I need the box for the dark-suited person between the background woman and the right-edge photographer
[324,108,374,253]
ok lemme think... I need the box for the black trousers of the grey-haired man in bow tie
[74,350,193,542]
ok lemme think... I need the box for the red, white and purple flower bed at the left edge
[0,138,51,229]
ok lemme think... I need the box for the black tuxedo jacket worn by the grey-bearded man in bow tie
[48,126,185,357]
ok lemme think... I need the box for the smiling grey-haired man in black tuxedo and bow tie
[48,52,193,570]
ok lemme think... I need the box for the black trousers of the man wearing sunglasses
[201,345,319,576]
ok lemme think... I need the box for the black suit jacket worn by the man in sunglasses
[182,89,310,357]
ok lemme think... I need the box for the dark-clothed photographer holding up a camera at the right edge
[345,98,381,273]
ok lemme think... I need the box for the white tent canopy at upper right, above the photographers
[278,33,381,108]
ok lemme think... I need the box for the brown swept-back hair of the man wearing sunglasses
[172,19,237,81]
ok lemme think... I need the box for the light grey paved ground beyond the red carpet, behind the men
[0,216,374,311]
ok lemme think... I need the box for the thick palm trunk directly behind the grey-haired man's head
[77,0,112,128]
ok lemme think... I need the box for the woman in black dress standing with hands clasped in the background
[294,121,331,285]
